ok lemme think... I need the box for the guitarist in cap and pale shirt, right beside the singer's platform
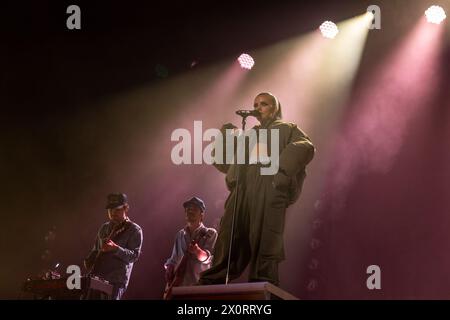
[164,197,217,287]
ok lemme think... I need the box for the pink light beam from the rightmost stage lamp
[328,21,443,211]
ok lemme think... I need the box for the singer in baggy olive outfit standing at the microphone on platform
[199,92,315,286]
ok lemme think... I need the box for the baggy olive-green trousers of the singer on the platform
[200,165,288,285]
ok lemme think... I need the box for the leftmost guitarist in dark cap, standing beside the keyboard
[84,193,142,300]
